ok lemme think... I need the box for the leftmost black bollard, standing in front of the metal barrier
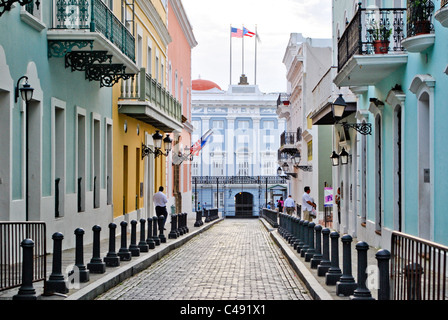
[12,239,37,300]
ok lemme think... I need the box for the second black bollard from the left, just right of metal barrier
[44,232,68,295]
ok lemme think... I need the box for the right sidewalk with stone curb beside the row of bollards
[260,219,378,300]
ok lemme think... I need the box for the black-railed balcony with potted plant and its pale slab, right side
[334,5,407,86]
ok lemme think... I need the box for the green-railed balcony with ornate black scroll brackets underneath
[47,0,138,86]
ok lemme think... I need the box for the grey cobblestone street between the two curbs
[98,219,312,300]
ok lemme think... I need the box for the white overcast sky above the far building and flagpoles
[182,0,332,92]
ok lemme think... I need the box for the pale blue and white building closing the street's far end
[192,76,286,217]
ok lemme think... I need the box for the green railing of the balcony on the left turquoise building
[53,0,135,62]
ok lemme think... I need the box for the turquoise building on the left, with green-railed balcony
[0,0,137,251]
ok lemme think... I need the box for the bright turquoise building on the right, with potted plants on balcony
[333,0,448,248]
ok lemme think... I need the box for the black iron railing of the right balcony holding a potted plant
[338,5,406,72]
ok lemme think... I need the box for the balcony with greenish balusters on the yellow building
[118,68,182,132]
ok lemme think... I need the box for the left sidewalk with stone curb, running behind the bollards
[0,214,222,301]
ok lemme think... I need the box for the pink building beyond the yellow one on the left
[167,0,197,213]
